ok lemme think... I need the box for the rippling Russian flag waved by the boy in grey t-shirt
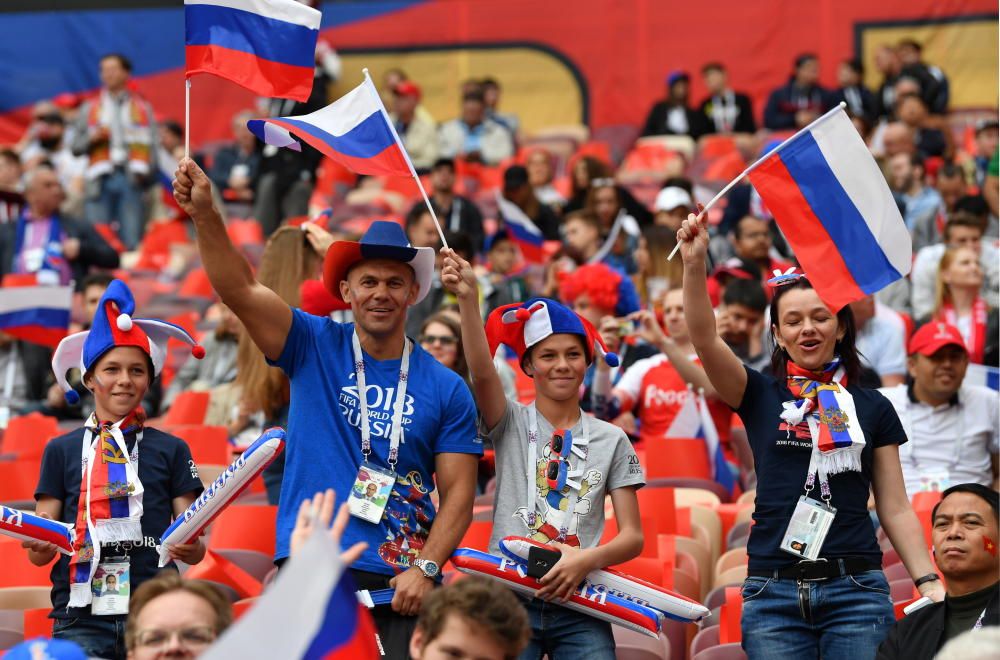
[247,69,416,176]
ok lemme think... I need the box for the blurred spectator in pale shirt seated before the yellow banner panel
[441,90,514,165]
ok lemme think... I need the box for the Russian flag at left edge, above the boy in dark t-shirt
[0,286,73,348]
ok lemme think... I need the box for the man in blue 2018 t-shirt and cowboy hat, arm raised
[174,159,482,657]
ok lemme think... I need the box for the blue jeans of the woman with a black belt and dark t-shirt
[741,570,896,660]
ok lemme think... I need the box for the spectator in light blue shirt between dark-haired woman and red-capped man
[851,295,906,387]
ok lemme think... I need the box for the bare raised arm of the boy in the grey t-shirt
[441,249,507,429]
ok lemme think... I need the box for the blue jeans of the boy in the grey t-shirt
[518,596,612,660]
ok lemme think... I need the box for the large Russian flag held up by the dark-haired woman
[748,105,913,311]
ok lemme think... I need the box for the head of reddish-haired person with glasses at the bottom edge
[125,572,233,660]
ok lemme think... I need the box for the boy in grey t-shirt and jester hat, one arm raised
[441,250,645,659]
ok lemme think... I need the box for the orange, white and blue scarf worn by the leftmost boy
[69,408,146,607]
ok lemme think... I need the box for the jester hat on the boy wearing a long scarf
[52,280,205,405]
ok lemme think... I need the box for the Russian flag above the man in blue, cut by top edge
[184,0,322,101]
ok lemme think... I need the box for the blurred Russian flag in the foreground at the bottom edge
[202,520,380,660]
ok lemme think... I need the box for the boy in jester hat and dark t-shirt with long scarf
[23,280,205,659]
